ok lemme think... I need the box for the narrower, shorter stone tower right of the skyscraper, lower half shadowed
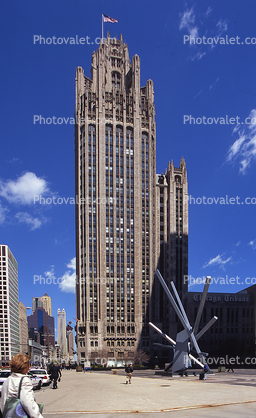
[150,157,188,362]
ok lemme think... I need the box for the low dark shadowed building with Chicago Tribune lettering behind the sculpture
[187,285,256,364]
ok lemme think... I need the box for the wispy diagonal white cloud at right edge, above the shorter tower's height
[226,109,256,174]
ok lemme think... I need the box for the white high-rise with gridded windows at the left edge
[0,245,20,364]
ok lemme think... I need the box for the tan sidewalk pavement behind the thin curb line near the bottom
[36,370,256,416]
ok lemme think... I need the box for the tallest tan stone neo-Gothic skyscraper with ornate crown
[75,35,187,360]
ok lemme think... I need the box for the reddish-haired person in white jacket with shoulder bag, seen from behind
[1,354,43,418]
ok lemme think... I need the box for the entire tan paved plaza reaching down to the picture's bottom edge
[33,370,256,418]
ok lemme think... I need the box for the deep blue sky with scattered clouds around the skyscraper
[0,0,256,340]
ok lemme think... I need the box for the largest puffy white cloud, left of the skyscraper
[0,172,49,205]
